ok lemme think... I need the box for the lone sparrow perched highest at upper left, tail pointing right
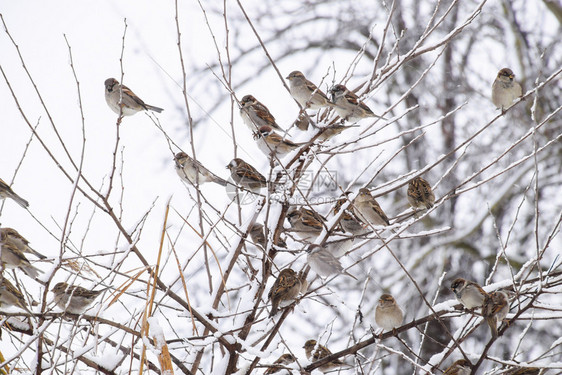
[104,78,163,116]
